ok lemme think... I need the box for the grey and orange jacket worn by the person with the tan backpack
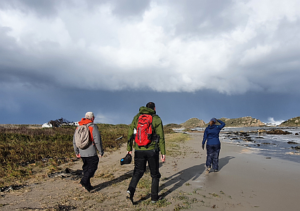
[73,118,104,157]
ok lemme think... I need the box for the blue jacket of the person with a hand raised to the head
[202,120,225,145]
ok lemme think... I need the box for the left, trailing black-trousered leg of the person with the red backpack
[127,150,147,203]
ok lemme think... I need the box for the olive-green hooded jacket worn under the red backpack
[127,106,166,155]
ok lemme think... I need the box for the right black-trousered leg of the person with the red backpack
[147,150,161,203]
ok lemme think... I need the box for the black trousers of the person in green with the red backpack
[128,150,161,201]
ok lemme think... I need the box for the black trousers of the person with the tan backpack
[81,155,99,187]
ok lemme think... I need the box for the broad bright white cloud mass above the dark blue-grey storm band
[0,0,300,94]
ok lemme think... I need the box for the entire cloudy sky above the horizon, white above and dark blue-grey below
[0,0,300,124]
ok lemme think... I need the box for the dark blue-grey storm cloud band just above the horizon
[0,87,300,124]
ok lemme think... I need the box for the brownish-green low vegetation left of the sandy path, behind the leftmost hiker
[0,124,129,187]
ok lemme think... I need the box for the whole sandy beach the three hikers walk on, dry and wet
[0,133,300,211]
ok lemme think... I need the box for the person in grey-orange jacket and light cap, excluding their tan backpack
[73,112,104,192]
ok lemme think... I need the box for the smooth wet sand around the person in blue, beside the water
[170,134,300,211]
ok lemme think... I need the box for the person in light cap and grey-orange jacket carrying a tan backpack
[73,112,104,192]
